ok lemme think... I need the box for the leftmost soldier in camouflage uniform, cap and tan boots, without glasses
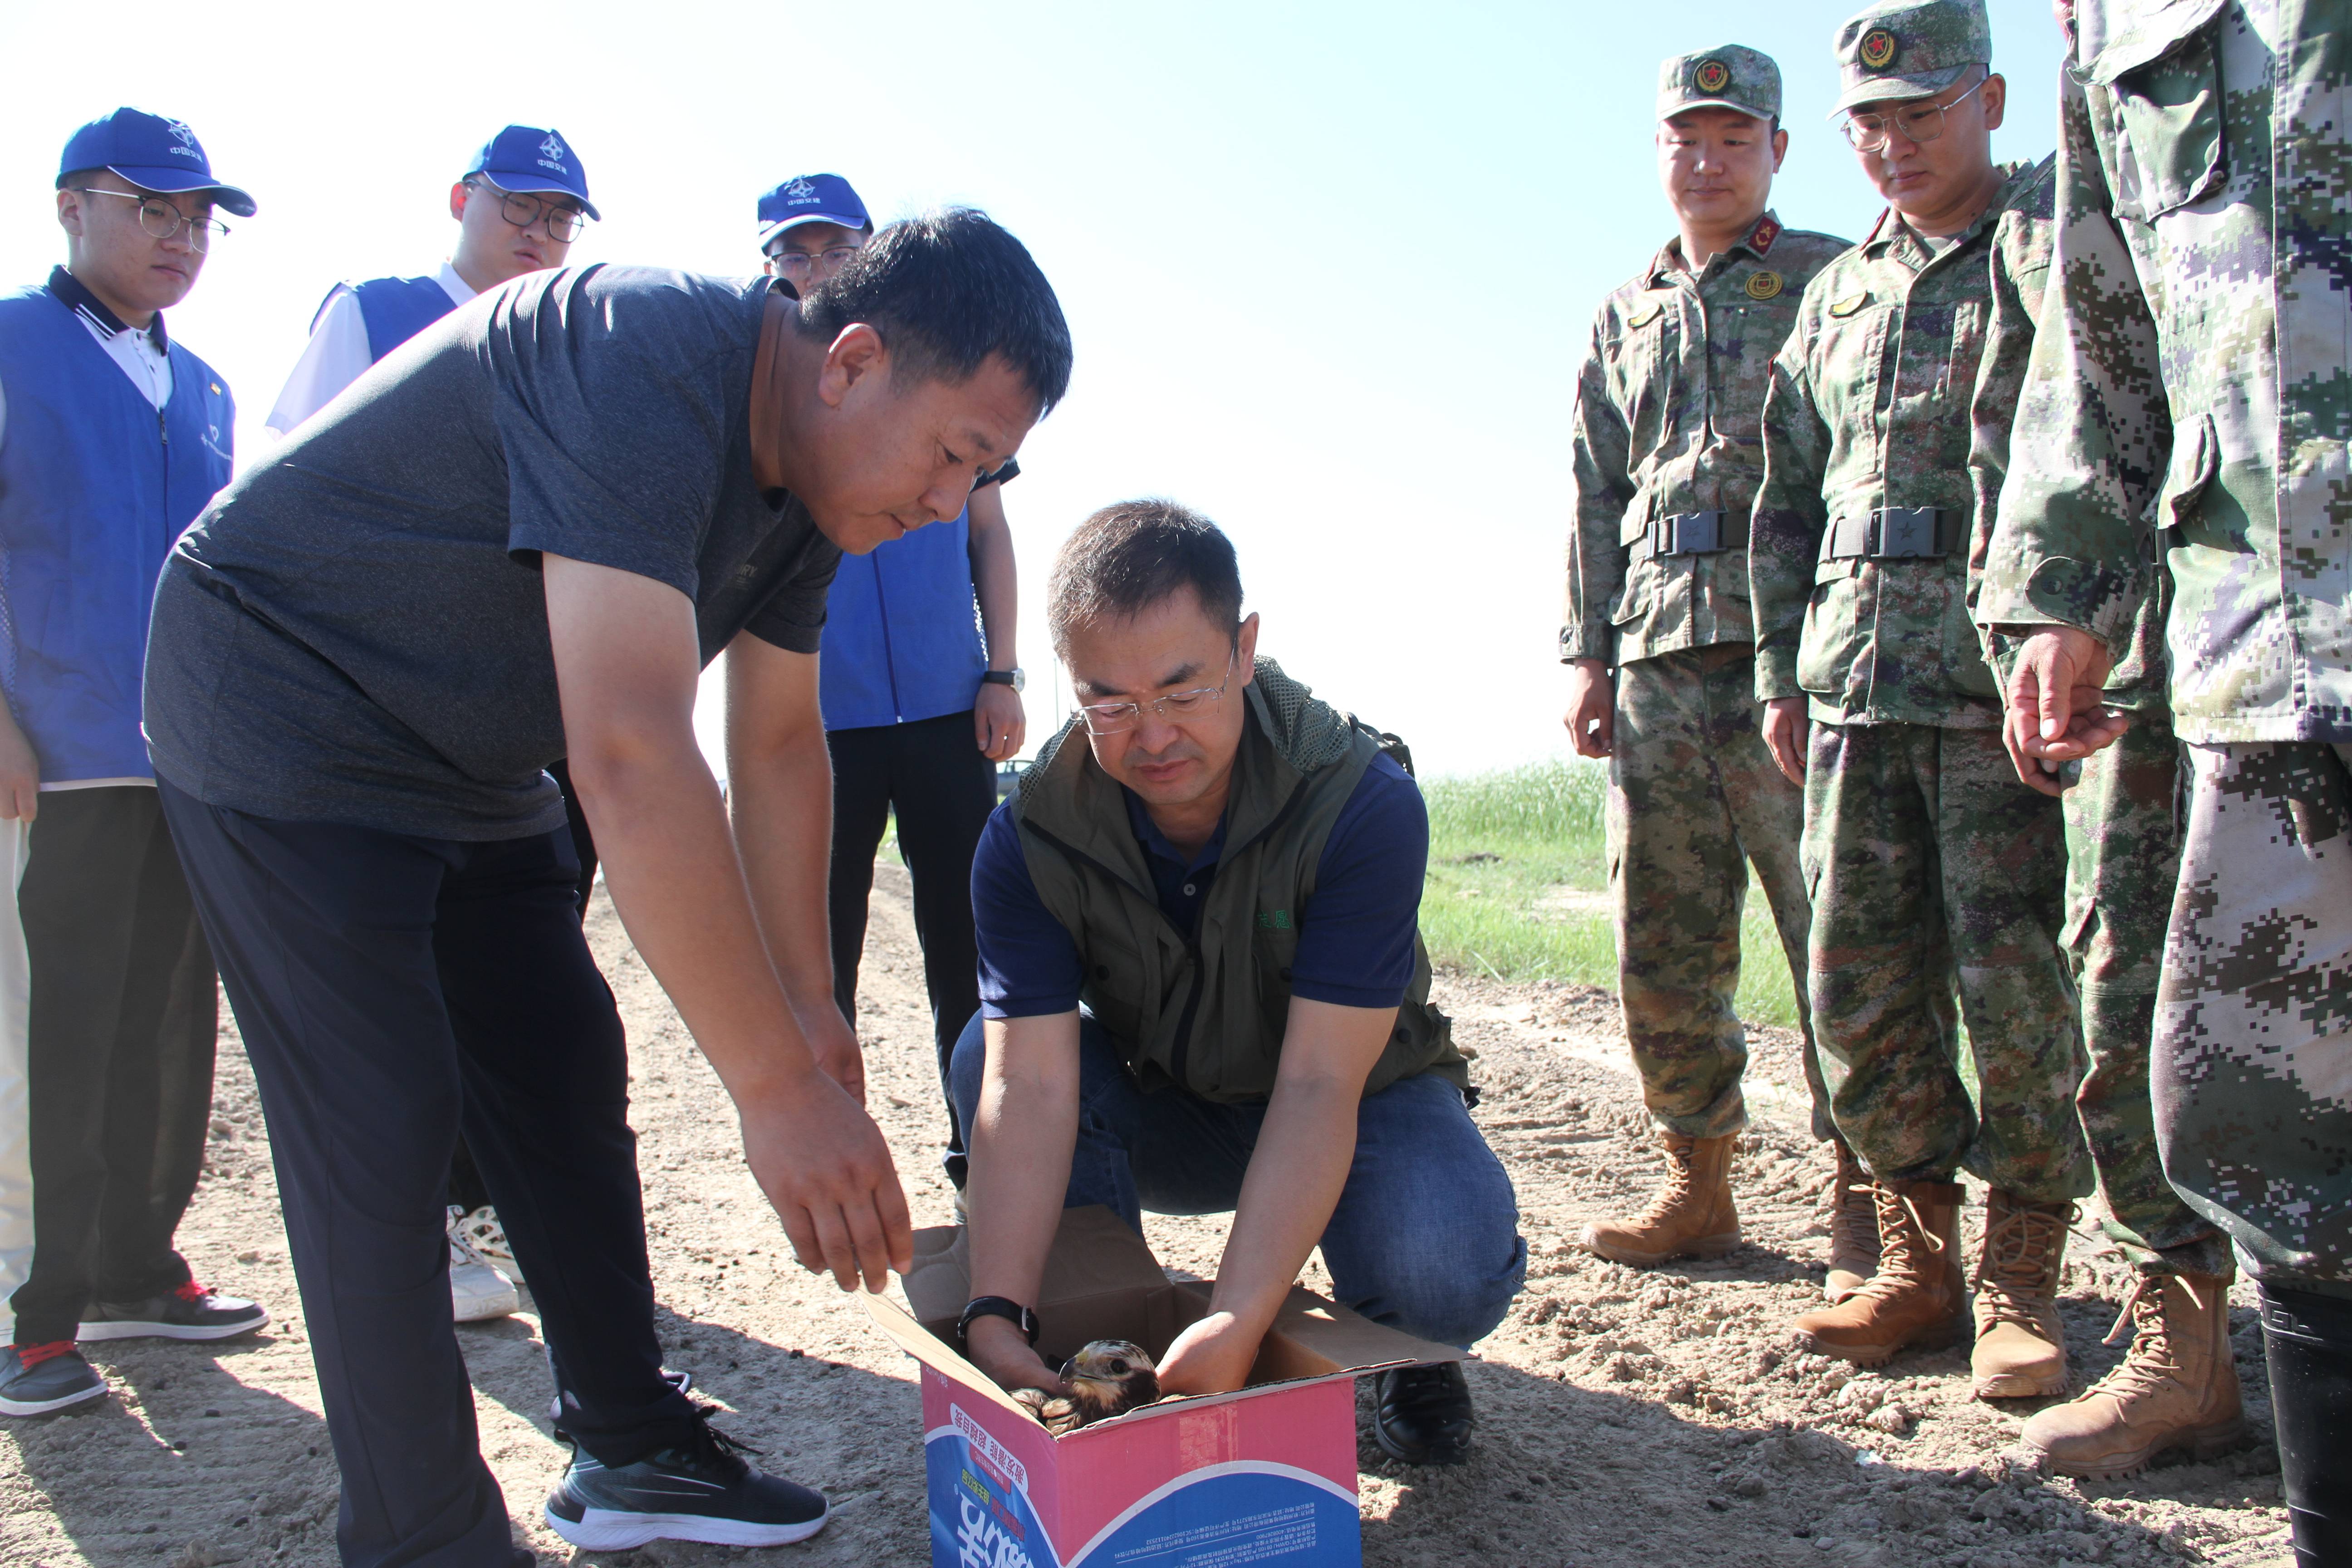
[1559,44,1877,1288]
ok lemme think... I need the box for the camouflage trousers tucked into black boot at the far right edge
[2150,740,2352,1295]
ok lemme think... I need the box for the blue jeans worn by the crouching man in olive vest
[950,1013,1526,1349]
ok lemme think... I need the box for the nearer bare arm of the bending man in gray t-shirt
[541,555,915,1291]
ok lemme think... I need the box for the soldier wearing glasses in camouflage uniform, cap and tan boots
[1748,0,2091,1399]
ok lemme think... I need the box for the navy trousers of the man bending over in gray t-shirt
[157,783,694,1568]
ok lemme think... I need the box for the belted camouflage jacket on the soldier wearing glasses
[1748,160,2051,729]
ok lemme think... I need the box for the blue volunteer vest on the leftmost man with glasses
[0,287,235,783]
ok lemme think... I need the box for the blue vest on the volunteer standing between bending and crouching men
[816,510,988,729]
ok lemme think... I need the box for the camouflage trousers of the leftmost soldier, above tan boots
[1609,642,1832,1138]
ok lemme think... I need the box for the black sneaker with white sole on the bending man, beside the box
[548,1413,826,1552]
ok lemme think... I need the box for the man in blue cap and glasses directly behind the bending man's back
[266,125,602,435]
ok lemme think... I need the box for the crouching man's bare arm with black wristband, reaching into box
[964,1011,1077,1387]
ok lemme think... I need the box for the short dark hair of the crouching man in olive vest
[1044,501,1242,658]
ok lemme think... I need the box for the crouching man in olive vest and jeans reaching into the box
[950,501,1526,1465]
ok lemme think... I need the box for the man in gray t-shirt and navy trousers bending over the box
[146,211,1070,1568]
